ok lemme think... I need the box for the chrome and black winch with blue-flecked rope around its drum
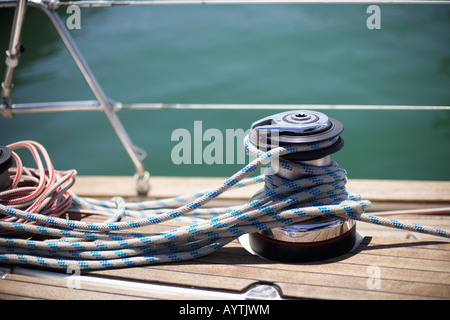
[249,110,357,262]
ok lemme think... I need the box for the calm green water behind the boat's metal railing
[0,5,450,180]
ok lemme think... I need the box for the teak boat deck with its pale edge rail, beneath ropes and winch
[0,177,450,300]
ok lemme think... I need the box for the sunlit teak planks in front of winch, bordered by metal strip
[86,232,450,299]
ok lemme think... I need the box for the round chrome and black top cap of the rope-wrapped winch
[249,110,344,147]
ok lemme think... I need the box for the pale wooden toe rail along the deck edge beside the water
[72,176,450,202]
